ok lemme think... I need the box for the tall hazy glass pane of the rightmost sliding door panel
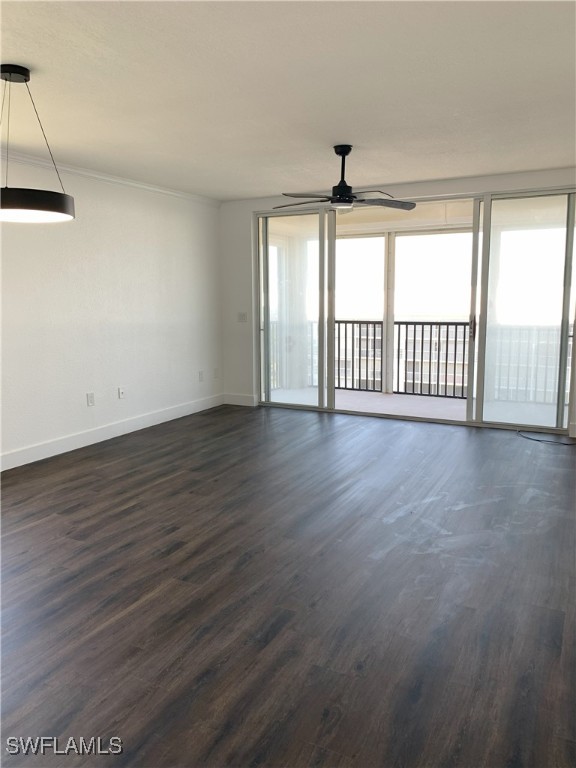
[484,195,567,427]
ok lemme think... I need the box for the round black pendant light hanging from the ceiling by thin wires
[0,64,74,224]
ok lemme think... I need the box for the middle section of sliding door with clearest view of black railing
[335,225,474,421]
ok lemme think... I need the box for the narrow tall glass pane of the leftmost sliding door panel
[267,214,319,406]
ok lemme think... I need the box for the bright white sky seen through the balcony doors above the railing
[269,228,576,326]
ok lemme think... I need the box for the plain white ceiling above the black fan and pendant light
[2,0,576,200]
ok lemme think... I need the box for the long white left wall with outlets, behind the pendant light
[2,164,223,468]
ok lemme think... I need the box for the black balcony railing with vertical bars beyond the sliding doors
[270,320,573,403]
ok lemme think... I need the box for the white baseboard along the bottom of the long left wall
[1,395,228,470]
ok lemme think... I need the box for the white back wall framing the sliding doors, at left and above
[220,168,576,408]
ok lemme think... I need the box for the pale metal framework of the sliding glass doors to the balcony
[253,182,576,434]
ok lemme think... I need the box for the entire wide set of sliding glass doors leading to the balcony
[259,192,576,430]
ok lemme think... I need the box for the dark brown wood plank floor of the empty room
[2,406,576,768]
